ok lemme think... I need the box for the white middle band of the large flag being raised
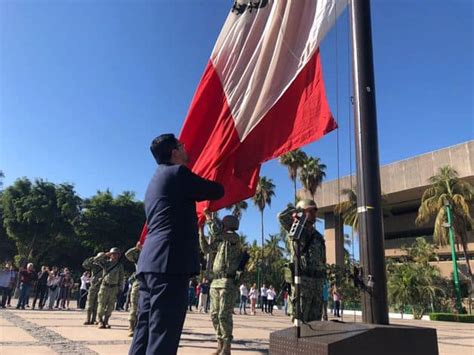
[211,0,347,141]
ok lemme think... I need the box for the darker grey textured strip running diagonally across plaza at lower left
[0,311,98,355]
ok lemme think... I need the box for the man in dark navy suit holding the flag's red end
[129,134,224,355]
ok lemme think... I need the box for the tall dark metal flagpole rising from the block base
[350,0,388,324]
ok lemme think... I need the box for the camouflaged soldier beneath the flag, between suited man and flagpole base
[199,210,242,355]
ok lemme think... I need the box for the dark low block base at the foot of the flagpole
[270,322,438,355]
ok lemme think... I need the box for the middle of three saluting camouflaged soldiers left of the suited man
[94,248,124,329]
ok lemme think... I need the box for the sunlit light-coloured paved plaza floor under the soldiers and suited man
[0,309,474,355]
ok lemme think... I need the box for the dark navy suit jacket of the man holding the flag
[137,164,224,275]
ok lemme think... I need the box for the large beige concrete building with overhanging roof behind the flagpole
[300,141,474,277]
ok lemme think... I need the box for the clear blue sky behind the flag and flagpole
[0,0,474,253]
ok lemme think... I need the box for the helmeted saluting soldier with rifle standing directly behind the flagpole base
[278,199,326,322]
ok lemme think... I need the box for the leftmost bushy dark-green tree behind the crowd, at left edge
[2,178,80,262]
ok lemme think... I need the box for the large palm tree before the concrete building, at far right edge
[416,165,474,280]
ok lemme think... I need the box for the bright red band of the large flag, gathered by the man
[180,51,337,221]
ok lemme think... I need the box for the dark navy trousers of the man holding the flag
[129,273,189,355]
